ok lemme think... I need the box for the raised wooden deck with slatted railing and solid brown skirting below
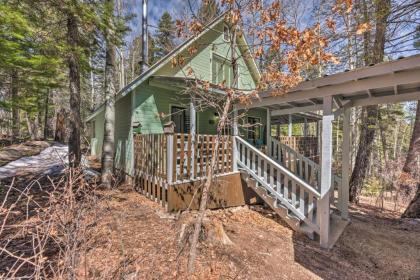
[134,133,245,211]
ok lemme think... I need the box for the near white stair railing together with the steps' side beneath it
[236,136,321,237]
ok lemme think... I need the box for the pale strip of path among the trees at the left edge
[0,144,68,180]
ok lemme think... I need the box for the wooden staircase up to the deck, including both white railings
[235,136,347,248]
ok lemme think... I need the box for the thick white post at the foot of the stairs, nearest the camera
[318,96,334,248]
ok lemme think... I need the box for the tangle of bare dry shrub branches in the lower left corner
[0,169,108,279]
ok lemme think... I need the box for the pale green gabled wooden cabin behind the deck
[87,16,267,175]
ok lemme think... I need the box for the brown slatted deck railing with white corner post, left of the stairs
[134,133,233,207]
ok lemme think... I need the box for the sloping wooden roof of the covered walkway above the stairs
[239,55,420,114]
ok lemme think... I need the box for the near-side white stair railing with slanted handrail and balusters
[235,136,321,233]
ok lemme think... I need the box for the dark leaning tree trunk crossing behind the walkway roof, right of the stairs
[349,0,391,203]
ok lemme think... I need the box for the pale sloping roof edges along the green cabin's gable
[85,13,260,121]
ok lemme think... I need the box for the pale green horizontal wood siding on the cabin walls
[91,19,266,177]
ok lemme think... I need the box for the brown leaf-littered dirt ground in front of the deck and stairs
[75,187,420,279]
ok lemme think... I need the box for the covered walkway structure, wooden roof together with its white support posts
[237,55,420,247]
